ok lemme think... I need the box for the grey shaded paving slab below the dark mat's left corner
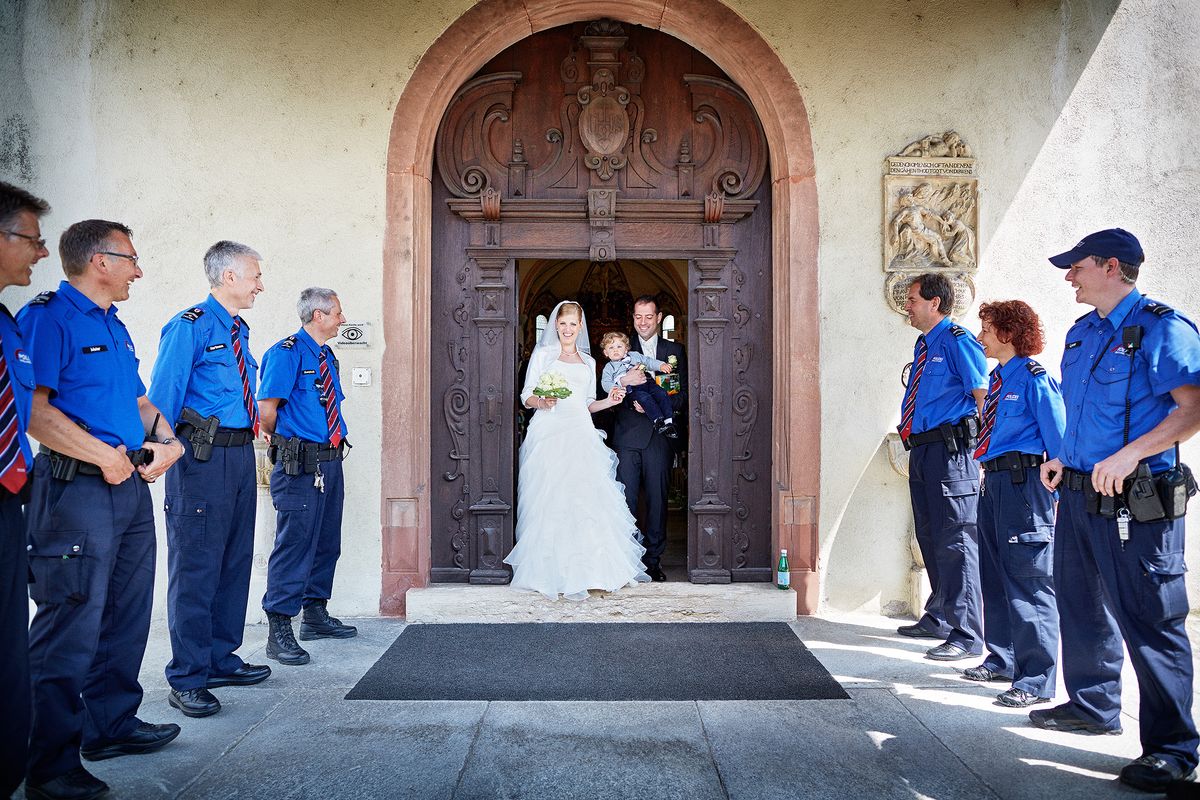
[178,690,486,800]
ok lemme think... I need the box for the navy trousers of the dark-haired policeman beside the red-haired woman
[908,441,983,654]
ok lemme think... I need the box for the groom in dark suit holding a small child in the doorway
[612,295,688,581]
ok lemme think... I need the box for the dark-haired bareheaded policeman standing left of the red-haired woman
[896,272,988,661]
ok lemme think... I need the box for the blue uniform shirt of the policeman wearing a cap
[1058,289,1200,473]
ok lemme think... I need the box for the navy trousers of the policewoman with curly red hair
[979,467,1058,697]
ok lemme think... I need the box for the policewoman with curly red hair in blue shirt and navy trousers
[962,300,1066,708]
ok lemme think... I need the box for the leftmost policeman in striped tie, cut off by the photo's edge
[0,181,50,798]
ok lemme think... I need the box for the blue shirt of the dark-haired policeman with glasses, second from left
[17,281,146,450]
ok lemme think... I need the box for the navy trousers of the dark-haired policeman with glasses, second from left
[28,456,155,783]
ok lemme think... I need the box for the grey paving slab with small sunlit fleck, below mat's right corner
[698,688,997,800]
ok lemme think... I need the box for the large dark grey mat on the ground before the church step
[346,622,848,700]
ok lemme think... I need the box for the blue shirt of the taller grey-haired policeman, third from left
[150,295,258,428]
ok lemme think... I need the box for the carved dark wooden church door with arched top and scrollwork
[431,20,772,583]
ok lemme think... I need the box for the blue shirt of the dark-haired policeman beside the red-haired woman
[901,317,988,433]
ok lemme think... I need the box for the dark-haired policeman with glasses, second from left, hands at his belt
[17,219,184,798]
